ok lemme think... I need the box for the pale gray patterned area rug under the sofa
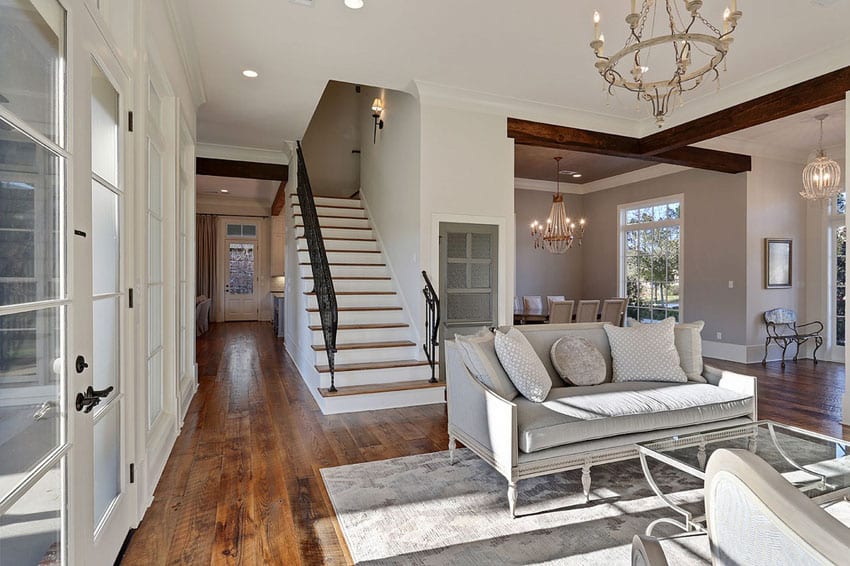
[321,449,710,566]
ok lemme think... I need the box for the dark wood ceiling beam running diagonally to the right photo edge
[640,67,850,155]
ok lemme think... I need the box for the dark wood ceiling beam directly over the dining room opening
[508,118,751,173]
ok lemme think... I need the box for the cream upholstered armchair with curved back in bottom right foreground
[632,449,850,566]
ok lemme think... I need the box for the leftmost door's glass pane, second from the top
[0,120,64,305]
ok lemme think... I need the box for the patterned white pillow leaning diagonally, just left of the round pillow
[495,328,552,403]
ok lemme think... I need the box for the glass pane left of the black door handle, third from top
[0,307,64,504]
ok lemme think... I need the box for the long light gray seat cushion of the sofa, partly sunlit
[514,381,753,453]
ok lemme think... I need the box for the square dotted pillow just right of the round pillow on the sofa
[604,317,688,383]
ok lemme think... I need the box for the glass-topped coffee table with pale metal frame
[637,421,850,535]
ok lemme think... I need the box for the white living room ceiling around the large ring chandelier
[182,0,850,149]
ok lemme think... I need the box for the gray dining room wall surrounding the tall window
[580,170,748,344]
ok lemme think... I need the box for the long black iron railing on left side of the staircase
[297,142,339,392]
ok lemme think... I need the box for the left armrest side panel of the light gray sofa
[445,340,518,479]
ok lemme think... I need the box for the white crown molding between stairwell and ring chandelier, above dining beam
[413,80,641,136]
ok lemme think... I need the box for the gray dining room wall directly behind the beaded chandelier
[514,190,594,306]
